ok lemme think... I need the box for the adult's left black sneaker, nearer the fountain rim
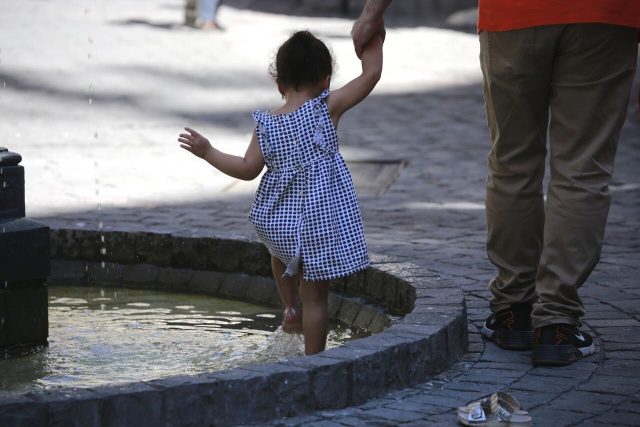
[481,304,533,350]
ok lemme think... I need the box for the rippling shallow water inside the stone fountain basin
[0,286,365,396]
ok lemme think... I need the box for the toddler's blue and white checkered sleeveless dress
[249,90,369,281]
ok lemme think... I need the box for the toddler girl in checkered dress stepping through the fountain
[178,31,383,354]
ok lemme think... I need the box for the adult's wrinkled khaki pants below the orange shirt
[480,24,638,328]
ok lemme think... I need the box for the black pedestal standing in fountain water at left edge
[0,147,50,359]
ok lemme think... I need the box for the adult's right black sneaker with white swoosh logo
[532,324,596,366]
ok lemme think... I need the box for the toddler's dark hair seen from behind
[270,31,333,90]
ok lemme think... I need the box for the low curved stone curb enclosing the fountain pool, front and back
[0,230,467,426]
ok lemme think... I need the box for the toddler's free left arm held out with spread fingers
[178,128,264,181]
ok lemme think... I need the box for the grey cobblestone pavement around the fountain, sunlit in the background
[0,0,640,426]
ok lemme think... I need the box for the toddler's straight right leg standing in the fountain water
[300,280,329,355]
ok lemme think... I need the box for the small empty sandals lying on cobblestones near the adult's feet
[457,391,532,427]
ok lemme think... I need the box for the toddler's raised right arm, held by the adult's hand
[327,34,382,126]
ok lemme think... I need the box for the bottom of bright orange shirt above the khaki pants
[478,0,640,31]
